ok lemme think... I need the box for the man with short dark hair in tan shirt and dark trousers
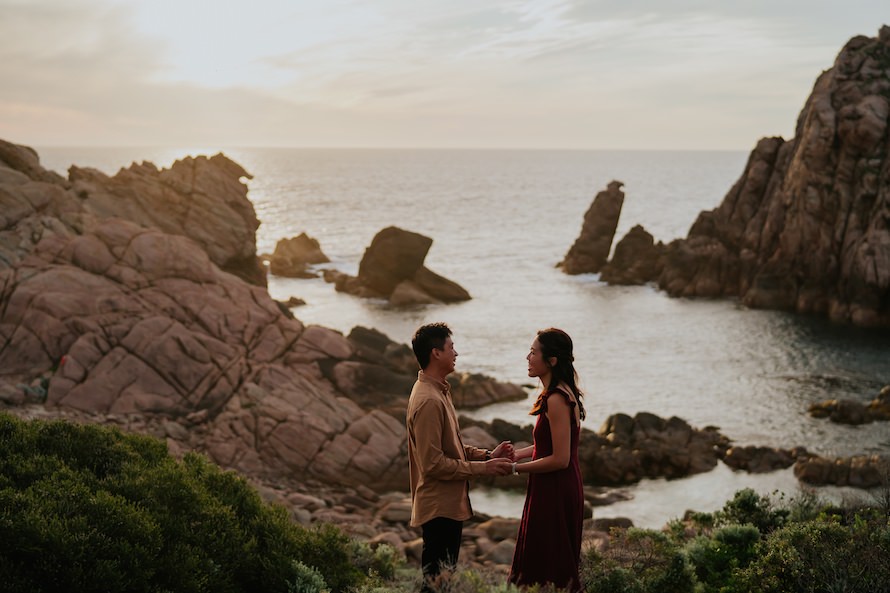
[406,323,513,592]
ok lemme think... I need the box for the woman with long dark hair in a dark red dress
[510,328,585,592]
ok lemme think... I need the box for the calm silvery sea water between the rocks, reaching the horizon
[39,148,890,527]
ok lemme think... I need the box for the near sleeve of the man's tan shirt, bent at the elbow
[414,400,482,480]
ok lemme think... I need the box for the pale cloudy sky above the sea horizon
[0,0,890,150]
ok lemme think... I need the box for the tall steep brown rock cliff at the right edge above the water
[596,26,890,328]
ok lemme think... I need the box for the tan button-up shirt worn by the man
[406,371,485,527]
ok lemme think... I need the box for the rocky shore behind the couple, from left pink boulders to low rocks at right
[0,135,880,568]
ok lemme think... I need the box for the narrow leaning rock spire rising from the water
[559,181,624,274]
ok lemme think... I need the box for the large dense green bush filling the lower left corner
[0,414,364,593]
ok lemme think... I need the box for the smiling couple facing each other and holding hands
[406,323,584,592]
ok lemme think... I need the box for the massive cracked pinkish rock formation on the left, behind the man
[0,143,524,490]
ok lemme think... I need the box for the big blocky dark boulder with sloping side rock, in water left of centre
[324,227,470,306]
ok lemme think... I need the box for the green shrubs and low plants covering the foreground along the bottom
[0,414,890,593]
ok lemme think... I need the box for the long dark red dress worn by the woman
[510,390,584,592]
